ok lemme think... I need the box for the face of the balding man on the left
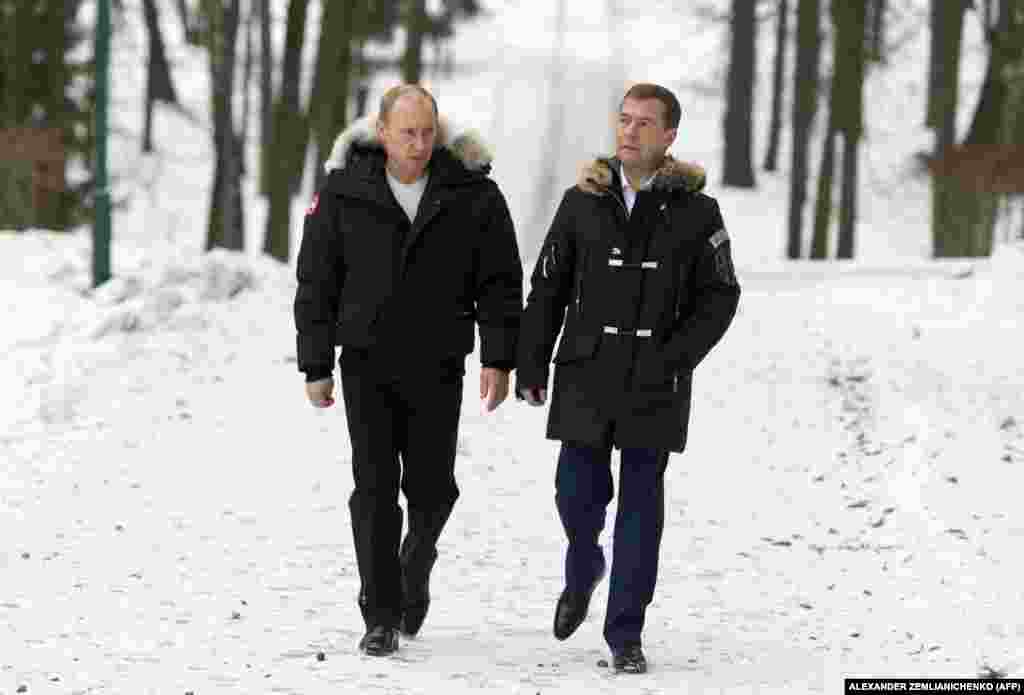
[377,94,437,183]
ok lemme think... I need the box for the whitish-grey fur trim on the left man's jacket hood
[324,116,494,174]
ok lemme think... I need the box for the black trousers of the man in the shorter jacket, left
[341,354,463,628]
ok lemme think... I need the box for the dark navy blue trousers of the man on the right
[555,443,669,649]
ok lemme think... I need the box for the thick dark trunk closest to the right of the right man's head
[722,0,757,188]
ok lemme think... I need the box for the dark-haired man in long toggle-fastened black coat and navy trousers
[516,84,739,672]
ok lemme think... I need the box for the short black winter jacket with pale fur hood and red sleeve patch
[295,119,522,381]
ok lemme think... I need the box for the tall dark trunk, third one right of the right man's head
[786,0,821,259]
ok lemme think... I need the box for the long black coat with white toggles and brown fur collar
[517,157,739,451]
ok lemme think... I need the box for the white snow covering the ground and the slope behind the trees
[0,0,1024,695]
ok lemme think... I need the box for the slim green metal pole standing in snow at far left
[92,0,111,287]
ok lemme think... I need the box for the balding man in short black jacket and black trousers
[295,85,522,655]
